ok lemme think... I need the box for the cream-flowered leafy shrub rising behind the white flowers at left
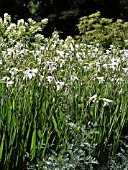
[0,13,48,50]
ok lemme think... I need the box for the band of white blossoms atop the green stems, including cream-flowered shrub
[0,14,128,105]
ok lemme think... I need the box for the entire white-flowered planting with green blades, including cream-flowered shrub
[0,14,128,170]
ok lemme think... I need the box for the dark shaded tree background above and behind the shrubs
[0,0,128,38]
